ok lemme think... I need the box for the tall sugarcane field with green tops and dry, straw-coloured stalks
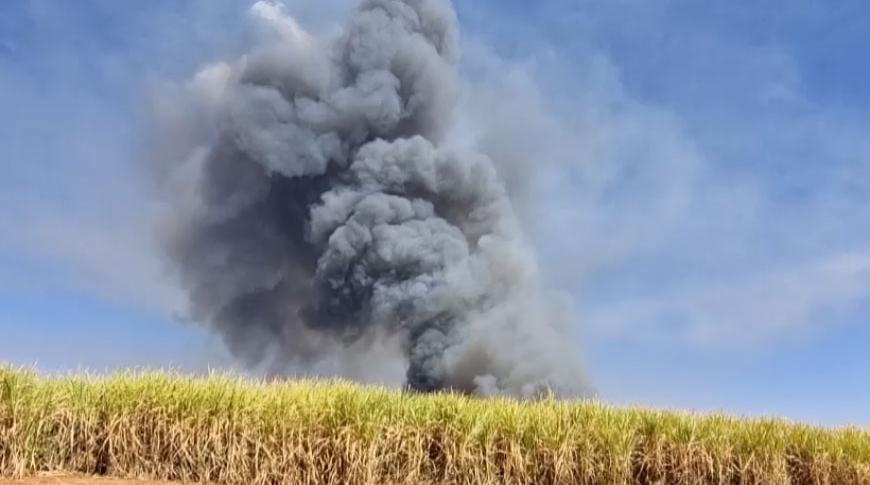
[0,367,870,485]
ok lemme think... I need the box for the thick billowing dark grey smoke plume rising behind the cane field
[155,0,586,396]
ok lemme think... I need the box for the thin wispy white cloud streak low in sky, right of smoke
[587,250,870,348]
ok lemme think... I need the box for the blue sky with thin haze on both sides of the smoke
[0,0,870,425]
